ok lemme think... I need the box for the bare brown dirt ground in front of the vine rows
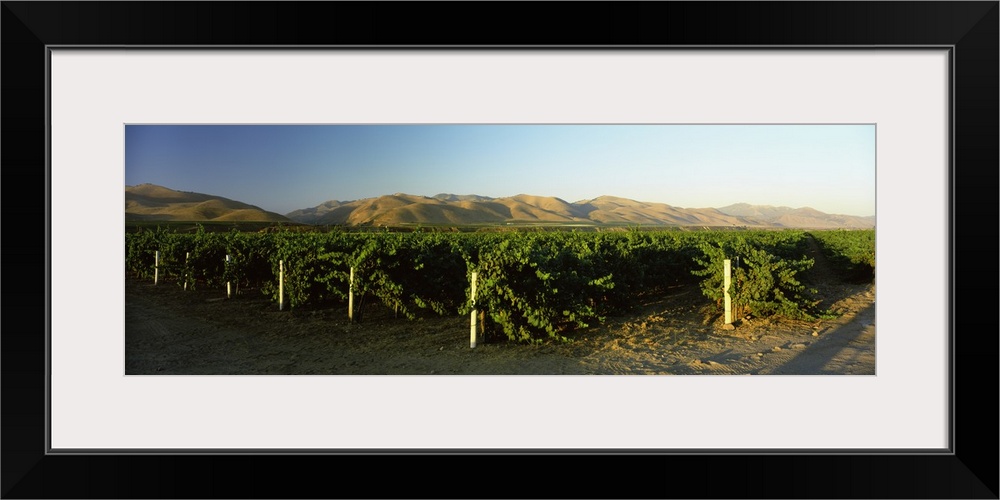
[125,280,875,375]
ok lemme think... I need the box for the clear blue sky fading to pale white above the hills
[125,125,875,216]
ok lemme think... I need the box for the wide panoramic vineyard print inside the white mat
[124,124,876,375]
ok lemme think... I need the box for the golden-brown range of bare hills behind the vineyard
[125,184,875,229]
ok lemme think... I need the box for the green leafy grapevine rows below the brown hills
[125,227,875,342]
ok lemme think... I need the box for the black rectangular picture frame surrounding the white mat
[0,1,1000,498]
